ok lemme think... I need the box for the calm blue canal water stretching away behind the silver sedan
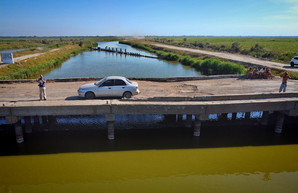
[45,41,201,79]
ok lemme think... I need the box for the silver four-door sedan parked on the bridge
[78,76,140,99]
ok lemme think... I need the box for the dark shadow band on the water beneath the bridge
[0,115,298,156]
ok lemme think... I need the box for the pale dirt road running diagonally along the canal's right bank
[151,43,298,72]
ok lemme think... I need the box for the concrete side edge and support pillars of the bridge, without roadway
[0,93,298,143]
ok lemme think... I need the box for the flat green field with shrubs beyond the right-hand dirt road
[149,36,298,63]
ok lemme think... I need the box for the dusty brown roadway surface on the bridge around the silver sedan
[0,77,298,102]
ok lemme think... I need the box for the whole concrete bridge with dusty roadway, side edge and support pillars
[0,75,298,143]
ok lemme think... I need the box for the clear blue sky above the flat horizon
[0,0,298,36]
